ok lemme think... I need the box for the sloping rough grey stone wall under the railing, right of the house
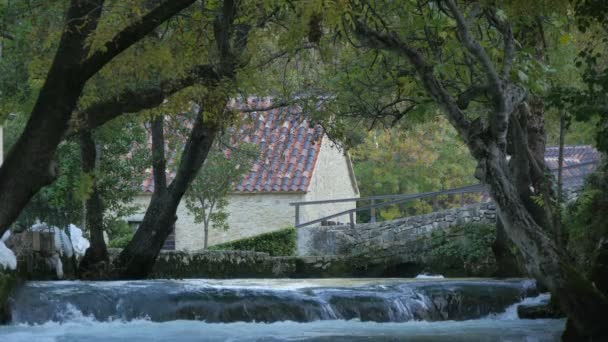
[297,202,496,257]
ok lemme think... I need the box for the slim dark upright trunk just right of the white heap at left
[80,129,109,274]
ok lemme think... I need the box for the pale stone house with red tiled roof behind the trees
[127,98,359,250]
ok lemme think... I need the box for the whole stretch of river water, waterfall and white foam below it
[0,279,564,342]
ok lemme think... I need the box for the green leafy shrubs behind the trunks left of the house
[4,113,149,228]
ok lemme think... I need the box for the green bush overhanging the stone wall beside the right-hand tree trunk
[431,223,496,274]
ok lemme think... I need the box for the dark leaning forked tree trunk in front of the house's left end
[115,0,240,279]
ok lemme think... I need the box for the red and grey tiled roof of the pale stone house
[142,98,323,193]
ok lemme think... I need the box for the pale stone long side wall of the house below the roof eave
[126,193,304,250]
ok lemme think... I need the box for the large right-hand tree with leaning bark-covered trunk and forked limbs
[354,4,608,340]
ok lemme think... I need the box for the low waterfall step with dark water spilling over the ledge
[12,279,537,324]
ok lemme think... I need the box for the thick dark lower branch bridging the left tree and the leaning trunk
[80,65,220,129]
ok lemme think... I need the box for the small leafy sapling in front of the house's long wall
[186,139,259,248]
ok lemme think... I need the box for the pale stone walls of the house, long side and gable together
[127,137,358,251]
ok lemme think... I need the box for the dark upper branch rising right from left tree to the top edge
[82,0,196,79]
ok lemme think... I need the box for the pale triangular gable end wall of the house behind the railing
[300,136,359,223]
